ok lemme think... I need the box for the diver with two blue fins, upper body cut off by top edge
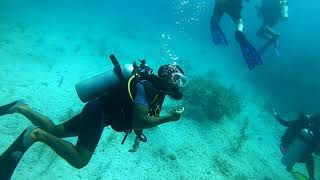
[210,0,263,70]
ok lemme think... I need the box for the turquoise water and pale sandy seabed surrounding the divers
[0,0,320,180]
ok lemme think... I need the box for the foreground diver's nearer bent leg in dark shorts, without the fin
[30,101,104,168]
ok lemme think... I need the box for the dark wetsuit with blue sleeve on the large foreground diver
[63,82,160,152]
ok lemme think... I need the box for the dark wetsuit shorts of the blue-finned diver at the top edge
[213,0,242,23]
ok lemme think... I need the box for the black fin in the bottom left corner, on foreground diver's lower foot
[0,126,35,180]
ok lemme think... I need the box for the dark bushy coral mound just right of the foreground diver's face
[183,72,242,121]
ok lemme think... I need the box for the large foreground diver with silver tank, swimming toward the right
[0,55,188,180]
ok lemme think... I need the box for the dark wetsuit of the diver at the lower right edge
[276,116,320,177]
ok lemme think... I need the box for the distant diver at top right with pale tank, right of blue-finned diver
[256,0,289,56]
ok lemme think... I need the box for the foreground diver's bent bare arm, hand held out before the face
[132,104,181,129]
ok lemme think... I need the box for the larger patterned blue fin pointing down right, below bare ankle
[235,31,263,70]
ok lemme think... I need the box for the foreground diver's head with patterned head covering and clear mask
[158,63,189,100]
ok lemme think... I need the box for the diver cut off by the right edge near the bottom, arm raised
[273,110,320,180]
